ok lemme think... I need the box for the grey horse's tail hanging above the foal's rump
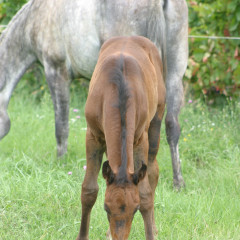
[147,0,167,79]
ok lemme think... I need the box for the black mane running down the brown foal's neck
[109,55,130,184]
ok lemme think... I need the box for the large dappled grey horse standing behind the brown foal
[0,0,188,187]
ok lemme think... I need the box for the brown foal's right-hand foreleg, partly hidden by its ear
[136,133,154,240]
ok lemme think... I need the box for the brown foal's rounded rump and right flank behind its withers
[99,36,165,118]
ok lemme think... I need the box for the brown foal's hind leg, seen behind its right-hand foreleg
[147,111,163,234]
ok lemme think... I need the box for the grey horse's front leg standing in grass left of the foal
[44,62,70,157]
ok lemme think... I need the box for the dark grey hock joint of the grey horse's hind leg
[165,113,180,145]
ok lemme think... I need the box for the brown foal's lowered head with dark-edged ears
[102,161,147,240]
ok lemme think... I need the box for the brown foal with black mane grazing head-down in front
[77,36,166,240]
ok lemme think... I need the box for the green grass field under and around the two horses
[0,85,240,240]
